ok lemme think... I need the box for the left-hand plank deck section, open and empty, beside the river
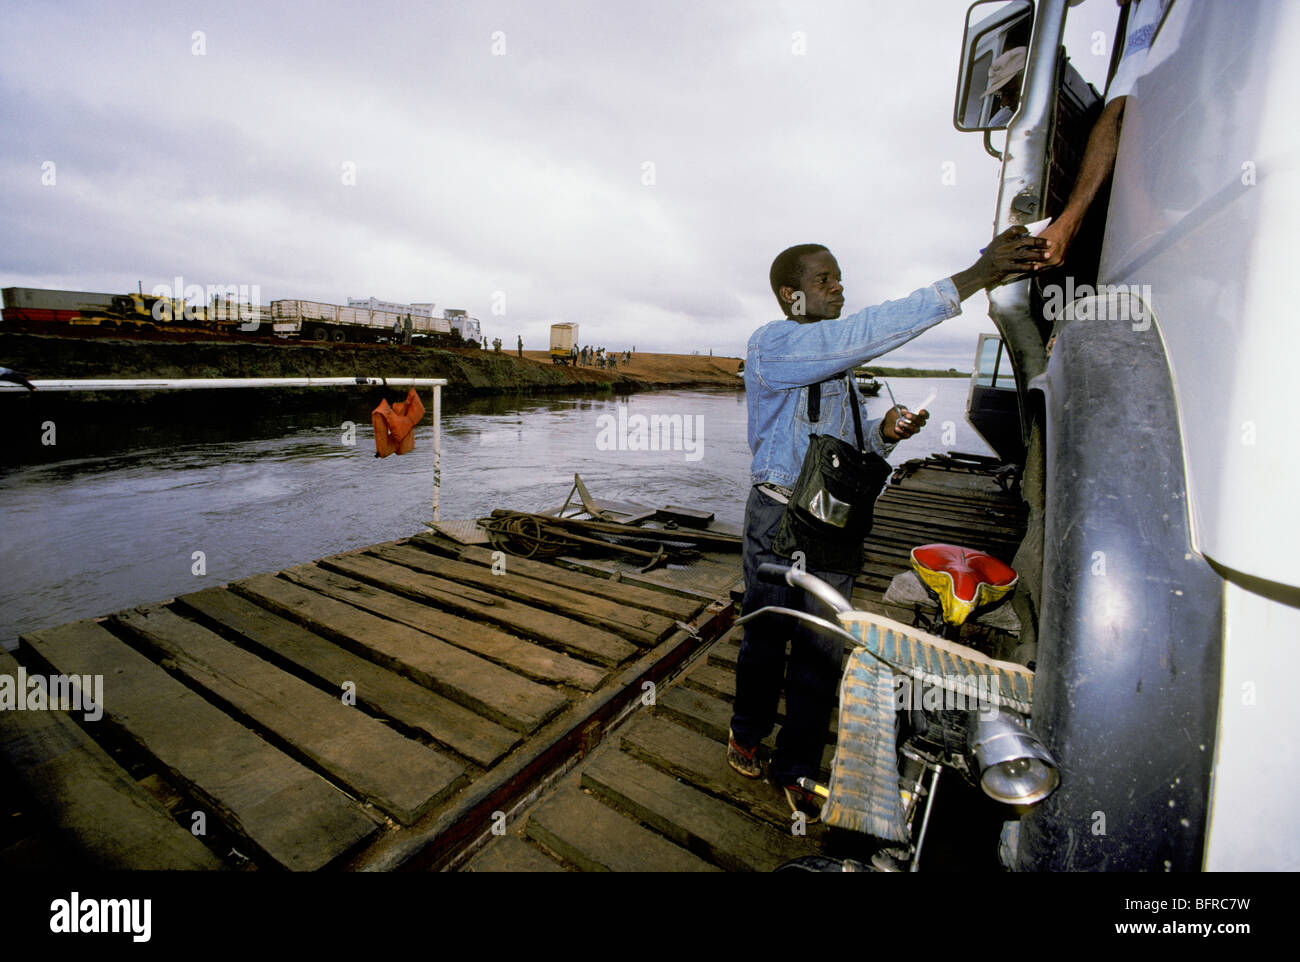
[0,536,738,870]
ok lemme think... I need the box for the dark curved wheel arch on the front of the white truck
[1015,295,1223,871]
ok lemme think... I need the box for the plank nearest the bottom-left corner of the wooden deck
[0,651,222,871]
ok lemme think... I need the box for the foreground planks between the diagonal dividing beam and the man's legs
[459,629,832,872]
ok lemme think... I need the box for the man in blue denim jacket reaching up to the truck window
[727,228,1047,820]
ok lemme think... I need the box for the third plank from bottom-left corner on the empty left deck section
[113,605,465,826]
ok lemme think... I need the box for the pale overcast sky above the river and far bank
[0,0,1117,369]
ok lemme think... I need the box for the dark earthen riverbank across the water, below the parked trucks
[0,334,741,397]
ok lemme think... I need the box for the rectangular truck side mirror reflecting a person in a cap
[953,0,1034,130]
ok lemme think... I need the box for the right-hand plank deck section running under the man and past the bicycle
[455,468,1024,872]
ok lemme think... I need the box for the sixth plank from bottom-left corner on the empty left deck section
[280,564,610,692]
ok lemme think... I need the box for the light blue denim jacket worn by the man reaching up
[745,278,962,488]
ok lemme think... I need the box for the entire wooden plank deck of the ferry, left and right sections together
[0,457,1024,871]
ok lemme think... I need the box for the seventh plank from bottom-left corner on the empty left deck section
[317,554,637,667]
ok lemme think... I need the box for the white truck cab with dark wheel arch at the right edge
[953,0,1300,871]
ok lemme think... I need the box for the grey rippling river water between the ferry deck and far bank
[0,378,989,649]
